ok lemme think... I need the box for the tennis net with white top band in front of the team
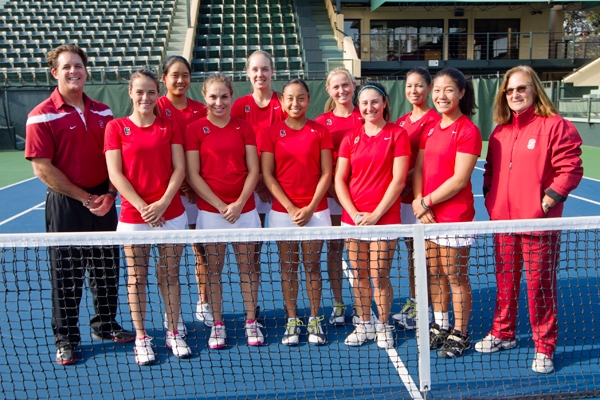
[0,218,600,399]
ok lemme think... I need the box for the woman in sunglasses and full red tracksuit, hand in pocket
[475,66,583,374]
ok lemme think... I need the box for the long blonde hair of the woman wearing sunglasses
[494,65,558,125]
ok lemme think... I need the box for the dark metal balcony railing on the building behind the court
[353,30,600,61]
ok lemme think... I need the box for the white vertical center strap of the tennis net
[413,224,431,392]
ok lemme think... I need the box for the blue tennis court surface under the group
[0,161,600,400]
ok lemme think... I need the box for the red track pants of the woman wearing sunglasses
[491,233,560,357]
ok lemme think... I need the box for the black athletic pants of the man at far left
[46,182,120,347]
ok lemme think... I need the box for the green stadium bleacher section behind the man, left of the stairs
[0,0,175,86]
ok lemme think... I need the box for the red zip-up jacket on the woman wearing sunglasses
[483,106,583,220]
